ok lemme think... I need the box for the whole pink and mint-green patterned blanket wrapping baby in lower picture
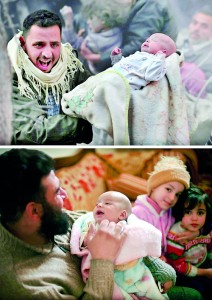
[71,212,165,300]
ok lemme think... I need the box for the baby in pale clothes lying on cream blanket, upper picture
[111,33,176,89]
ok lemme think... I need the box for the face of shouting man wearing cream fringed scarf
[22,25,61,73]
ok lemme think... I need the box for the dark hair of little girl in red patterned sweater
[173,183,212,233]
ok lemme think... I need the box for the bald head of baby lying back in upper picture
[141,33,177,57]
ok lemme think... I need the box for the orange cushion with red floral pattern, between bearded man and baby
[55,153,106,211]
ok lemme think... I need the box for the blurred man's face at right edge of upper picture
[189,13,212,44]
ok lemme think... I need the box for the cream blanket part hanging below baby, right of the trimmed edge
[129,53,190,145]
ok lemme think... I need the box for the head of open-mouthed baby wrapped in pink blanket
[93,191,131,224]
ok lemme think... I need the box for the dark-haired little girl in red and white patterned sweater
[166,184,212,299]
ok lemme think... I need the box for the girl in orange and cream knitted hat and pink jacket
[132,156,190,255]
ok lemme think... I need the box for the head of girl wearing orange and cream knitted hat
[147,156,190,210]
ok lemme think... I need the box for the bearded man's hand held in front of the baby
[87,220,127,262]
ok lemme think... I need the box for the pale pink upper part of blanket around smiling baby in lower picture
[71,212,162,280]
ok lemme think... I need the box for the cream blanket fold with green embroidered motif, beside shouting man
[61,71,130,145]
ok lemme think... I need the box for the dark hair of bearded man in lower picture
[0,149,54,222]
